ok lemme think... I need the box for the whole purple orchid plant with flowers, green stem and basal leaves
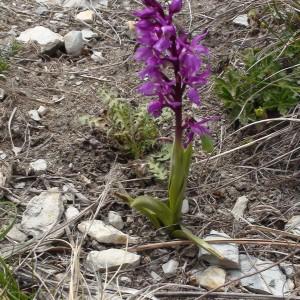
[116,0,221,257]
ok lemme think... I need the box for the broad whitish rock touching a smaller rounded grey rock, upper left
[17,26,63,53]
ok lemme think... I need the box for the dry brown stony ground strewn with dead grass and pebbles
[0,0,300,299]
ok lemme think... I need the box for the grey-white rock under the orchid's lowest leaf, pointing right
[199,230,240,269]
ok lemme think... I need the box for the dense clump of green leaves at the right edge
[215,38,300,124]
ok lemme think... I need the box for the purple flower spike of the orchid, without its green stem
[135,0,210,146]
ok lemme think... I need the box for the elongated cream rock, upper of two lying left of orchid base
[78,220,136,245]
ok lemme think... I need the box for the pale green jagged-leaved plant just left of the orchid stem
[99,89,158,159]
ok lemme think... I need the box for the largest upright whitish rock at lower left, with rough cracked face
[20,188,64,238]
